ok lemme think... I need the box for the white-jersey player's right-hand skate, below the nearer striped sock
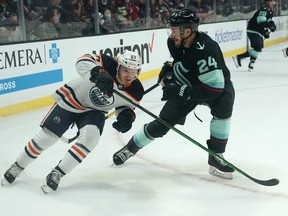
[41,169,63,194]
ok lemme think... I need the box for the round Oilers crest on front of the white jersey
[89,86,114,107]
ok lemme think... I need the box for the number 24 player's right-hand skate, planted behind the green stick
[208,153,234,179]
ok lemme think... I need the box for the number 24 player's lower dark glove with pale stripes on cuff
[161,85,192,101]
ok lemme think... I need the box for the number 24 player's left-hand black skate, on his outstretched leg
[113,137,140,166]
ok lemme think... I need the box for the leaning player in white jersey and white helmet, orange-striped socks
[1,51,144,193]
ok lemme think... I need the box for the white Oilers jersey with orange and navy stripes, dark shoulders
[53,54,144,113]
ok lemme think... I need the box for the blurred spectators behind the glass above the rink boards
[0,0,288,43]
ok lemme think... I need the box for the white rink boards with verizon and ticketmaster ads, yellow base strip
[0,16,288,117]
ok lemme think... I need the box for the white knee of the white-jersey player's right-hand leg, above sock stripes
[77,125,100,152]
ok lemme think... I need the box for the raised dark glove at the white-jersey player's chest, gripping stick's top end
[90,66,113,97]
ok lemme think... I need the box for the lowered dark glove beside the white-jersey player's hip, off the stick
[112,109,136,133]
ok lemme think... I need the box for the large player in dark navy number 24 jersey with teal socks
[113,9,235,179]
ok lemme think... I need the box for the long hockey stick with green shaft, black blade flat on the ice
[113,89,280,186]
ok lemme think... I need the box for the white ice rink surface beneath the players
[0,43,288,216]
